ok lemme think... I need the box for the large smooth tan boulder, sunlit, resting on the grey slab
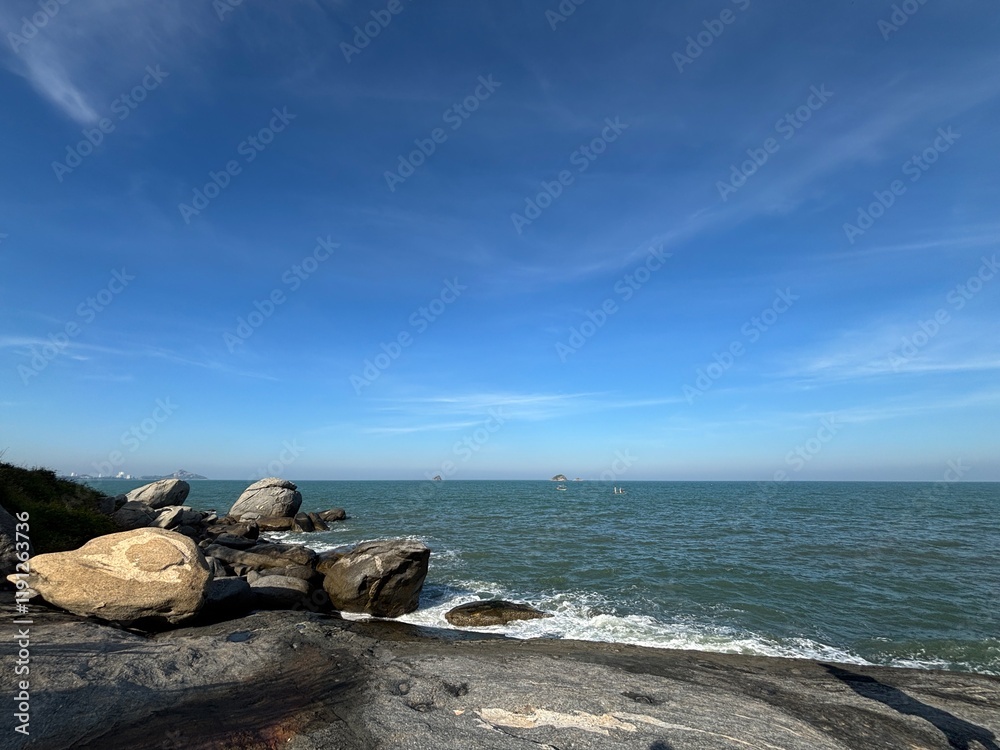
[11,529,211,625]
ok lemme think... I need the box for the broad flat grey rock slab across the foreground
[0,606,1000,750]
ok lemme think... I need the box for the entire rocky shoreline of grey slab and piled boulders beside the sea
[0,478,1000,750]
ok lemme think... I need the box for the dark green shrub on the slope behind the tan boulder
[0,462,119,555]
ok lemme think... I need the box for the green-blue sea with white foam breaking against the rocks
[91,480,1000,675]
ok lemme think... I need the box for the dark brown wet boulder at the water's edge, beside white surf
[323,539,431,617]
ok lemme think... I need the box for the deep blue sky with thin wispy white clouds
[0,0,1000,486]
